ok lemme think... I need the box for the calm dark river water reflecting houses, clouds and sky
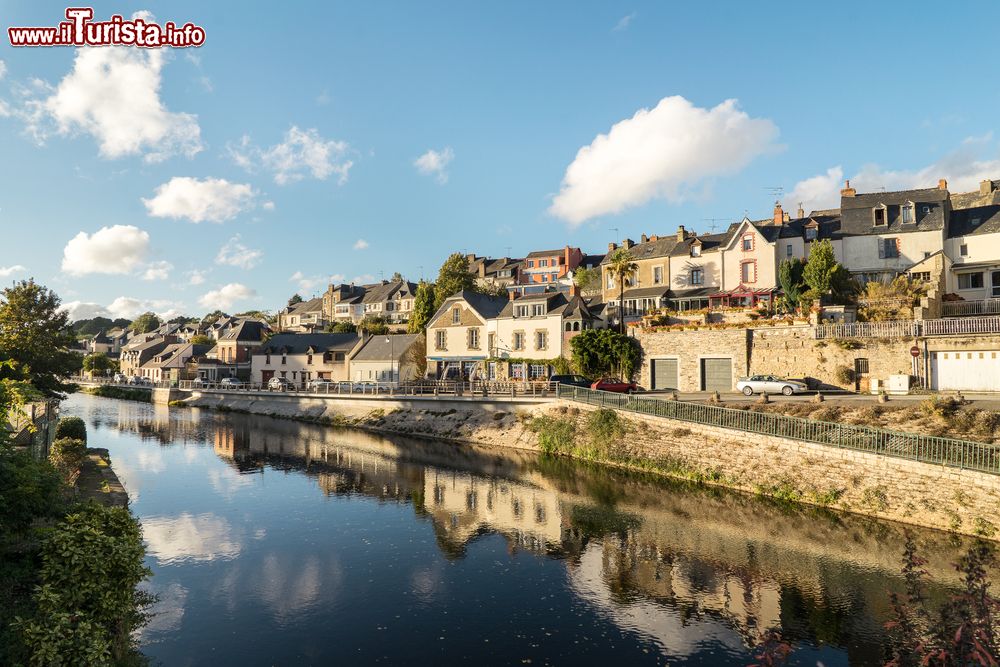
[63,395,976,666]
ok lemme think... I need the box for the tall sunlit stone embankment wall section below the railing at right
[553,401,1000,539]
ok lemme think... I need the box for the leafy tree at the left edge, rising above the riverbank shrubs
[0,280,80,396]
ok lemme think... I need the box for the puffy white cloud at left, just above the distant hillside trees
[62,225,149,276]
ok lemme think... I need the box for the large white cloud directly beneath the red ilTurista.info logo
[19,47,202,162]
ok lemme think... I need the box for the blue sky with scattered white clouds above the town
[0,0,1000,316]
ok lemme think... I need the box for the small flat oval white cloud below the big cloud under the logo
[142,176,255,222]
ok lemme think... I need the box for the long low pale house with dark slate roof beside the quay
[250,333,364,387]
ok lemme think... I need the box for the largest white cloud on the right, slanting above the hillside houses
[549,96,780,225]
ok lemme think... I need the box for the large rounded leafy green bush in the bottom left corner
[14,503,152,665]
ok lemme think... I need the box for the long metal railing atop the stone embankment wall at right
[557,385,1000,474]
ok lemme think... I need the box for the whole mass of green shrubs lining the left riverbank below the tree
[0,408,153,665]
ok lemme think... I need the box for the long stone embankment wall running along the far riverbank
[187,392,1000,539]
